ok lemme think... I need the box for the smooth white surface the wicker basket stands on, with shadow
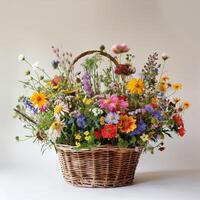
[0,168,200,200]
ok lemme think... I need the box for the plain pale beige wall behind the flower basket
[0,0,200,192]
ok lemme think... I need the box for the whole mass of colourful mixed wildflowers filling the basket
[14,44,190,153]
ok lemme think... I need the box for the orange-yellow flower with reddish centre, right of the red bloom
[118,115,137,133]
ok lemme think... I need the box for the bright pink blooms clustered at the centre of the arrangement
[99,95,128,112]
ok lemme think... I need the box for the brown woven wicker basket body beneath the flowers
[57,144,142,187]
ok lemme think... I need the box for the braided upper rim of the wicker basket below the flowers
[56,144,143,152]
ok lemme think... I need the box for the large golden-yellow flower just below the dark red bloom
[127,78,144,94]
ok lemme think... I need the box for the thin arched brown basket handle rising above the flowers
[71,50,119,67]
